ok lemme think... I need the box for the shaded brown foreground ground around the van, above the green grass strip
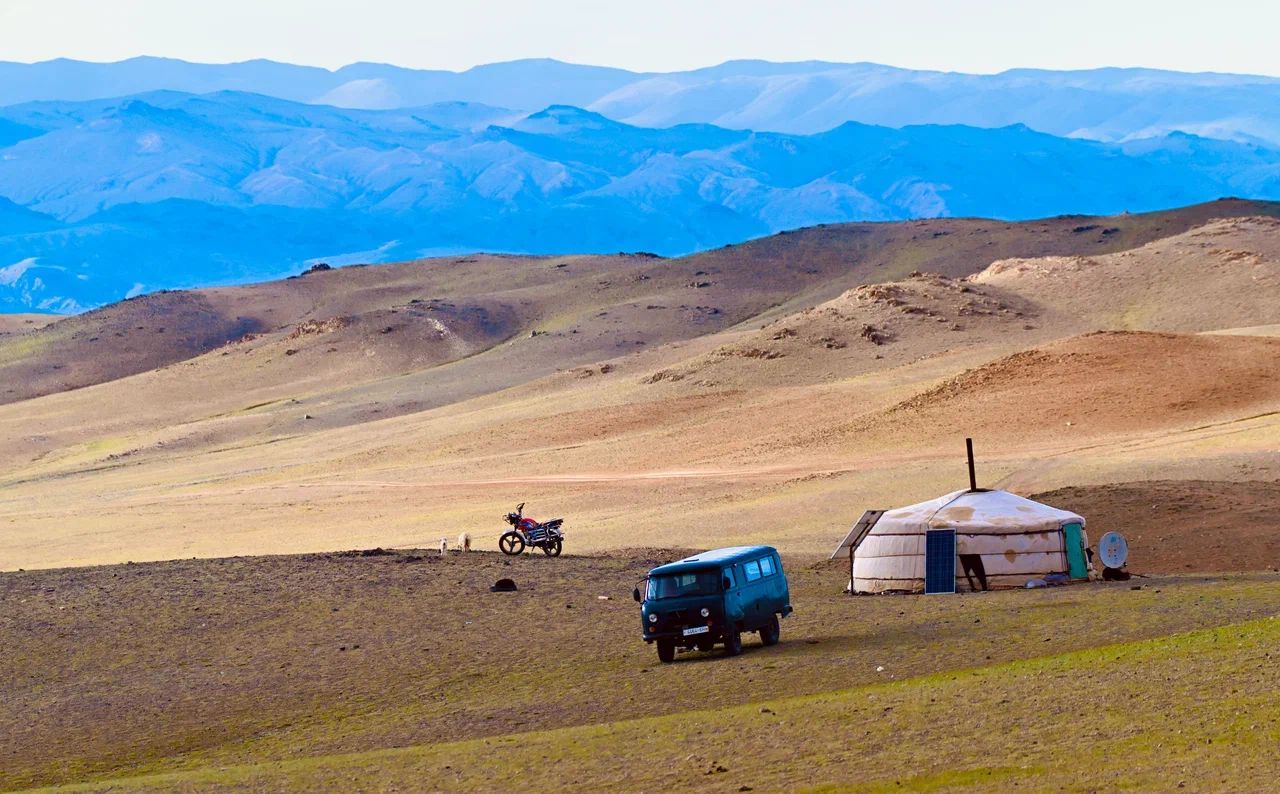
[0,549,1280,790]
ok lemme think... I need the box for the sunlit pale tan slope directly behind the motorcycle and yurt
[0,322,1280,567]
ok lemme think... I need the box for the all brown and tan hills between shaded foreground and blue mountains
[0,201,1280,566]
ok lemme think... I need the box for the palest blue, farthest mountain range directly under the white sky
[0,58,1280,143]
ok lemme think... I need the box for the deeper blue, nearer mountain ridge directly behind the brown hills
[0,81,1280,311]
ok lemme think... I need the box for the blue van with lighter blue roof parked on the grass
[631,546,791,662]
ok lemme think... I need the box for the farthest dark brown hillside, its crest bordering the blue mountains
[0,200,1280,402]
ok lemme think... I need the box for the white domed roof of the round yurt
[872,490,1084,534]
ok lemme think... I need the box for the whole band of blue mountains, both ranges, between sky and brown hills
[0,59,1280,311]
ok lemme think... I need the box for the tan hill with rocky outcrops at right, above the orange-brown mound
[629,216,1280,394]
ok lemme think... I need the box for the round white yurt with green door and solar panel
[833,489,1089,593]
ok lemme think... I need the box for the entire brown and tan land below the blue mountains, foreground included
[0,200,1280,791]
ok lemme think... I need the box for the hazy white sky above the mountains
[0,0,1280,76]
